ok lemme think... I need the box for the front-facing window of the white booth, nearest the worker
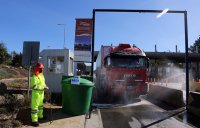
[47,56,64,73]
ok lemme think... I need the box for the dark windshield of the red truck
[110,57,147,68]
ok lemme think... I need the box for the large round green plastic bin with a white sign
[61,77,94,116]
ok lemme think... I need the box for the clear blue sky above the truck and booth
[0,0,200,52]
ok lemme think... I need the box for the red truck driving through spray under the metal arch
[95,44,149,101]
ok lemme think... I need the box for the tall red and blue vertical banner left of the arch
[74,19,92,62]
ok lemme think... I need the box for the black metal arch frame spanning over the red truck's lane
[91,9,189,110]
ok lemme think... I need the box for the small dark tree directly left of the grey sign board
[11,51,22,66]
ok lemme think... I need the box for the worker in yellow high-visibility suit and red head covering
[31,62,48,127]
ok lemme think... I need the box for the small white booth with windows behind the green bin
[39,49,74,93]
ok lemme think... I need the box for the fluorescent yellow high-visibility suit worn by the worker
[31,74,46,122]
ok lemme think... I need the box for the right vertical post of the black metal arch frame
[184,11,189,111]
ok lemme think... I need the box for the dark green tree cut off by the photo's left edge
[0,42,11,64]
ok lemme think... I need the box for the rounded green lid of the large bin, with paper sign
[62,77,94,86]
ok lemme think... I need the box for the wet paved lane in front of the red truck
[100,99,192,128]
